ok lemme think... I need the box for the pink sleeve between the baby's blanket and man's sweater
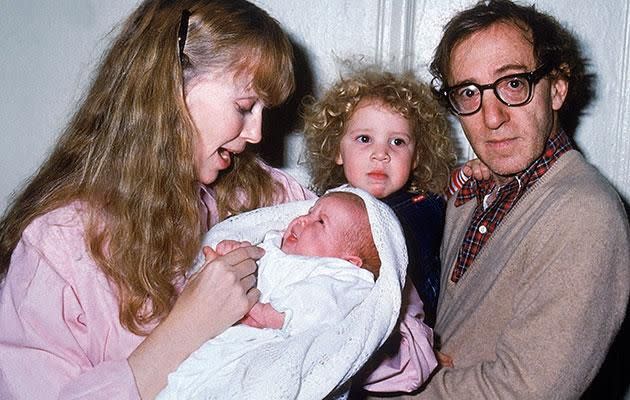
[362,280,437,392]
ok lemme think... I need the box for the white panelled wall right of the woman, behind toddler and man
[254,0,630,206]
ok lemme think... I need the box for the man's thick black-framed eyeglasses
[440,65,550,115]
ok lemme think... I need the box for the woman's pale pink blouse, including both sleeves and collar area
[0,163,435,400]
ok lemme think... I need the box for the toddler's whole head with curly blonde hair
[304,67,455,198]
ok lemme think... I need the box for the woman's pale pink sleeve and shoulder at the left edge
[0,206,142,400]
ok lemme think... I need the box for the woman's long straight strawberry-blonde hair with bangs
[0,0,294,334]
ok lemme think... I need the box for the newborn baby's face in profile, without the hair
[281,195,361,258]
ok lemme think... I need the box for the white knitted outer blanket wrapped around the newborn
[158,186,407,400]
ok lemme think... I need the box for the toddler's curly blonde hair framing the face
[303,65,456,194]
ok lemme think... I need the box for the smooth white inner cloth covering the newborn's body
[158,231,374,399]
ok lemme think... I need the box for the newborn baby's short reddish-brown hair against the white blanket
[325,192,381,279]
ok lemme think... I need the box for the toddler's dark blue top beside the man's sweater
[382,190,446,327]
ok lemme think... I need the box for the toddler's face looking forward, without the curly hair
[336,101,416,198]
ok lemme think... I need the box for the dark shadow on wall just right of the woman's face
[256,40,314,168]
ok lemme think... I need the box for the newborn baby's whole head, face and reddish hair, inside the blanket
[281,192,381,278]
